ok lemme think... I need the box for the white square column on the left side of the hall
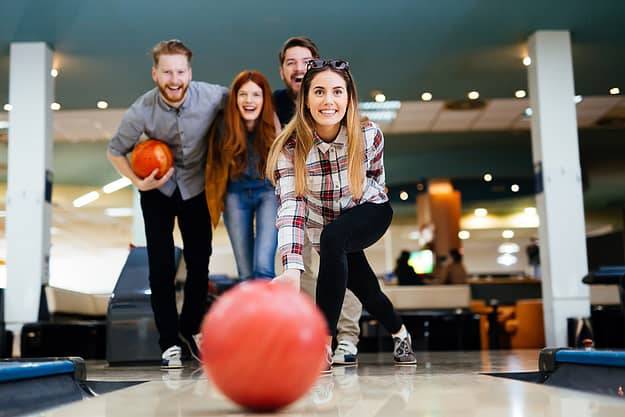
[5,42,54,332]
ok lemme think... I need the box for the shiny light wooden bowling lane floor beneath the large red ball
[38,351,625,417]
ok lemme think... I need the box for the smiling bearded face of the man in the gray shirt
[152,55,191,108]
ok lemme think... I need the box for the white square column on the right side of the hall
[528,31,590,346]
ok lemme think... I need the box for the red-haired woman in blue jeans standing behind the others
[205,71,279,281]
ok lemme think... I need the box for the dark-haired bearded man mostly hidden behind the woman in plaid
[273,36,362,365]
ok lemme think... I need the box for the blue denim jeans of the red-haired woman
[224,187,278,280]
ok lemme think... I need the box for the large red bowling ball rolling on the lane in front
[200,281,328,411]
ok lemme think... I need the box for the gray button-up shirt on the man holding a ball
[108,81,229,200]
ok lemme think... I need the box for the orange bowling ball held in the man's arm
[130,139,174,179]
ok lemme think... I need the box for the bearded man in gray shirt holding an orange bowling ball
[107,39,228,369]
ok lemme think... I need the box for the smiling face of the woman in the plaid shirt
[306,69,349,142]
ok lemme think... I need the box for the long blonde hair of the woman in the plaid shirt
[266,66,365,200]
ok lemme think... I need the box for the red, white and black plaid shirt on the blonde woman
[274,122,388,270]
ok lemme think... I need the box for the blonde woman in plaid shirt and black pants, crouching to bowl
[267,59,416,370]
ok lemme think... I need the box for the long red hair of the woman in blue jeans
[223,71,276,178]
